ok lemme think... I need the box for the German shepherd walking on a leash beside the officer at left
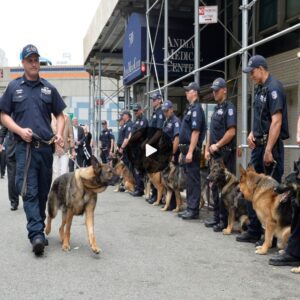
[45,156,118,254]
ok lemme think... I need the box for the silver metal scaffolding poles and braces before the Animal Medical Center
[90,0,300,162]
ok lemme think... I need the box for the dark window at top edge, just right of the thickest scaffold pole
[259,0,277,31]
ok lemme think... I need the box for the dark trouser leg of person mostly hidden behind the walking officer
[6,153,19,207]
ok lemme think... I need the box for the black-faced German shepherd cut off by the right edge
[275,159,300,273]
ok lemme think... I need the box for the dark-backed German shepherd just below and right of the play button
[161,162,186,212]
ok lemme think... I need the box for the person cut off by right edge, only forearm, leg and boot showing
[269,115,300,267]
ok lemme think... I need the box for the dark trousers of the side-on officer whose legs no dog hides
[183,150,201,212]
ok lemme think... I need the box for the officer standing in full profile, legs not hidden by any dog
[178,82,206,220]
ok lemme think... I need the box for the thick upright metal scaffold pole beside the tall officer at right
[241,0,248,168]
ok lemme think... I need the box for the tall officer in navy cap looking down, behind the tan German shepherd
[236,55,289,243]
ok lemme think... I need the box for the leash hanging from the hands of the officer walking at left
[21,132,56,197]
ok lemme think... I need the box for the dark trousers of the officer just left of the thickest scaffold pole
[211,150,235,226]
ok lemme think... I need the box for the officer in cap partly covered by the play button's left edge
[131,103,148,197]
